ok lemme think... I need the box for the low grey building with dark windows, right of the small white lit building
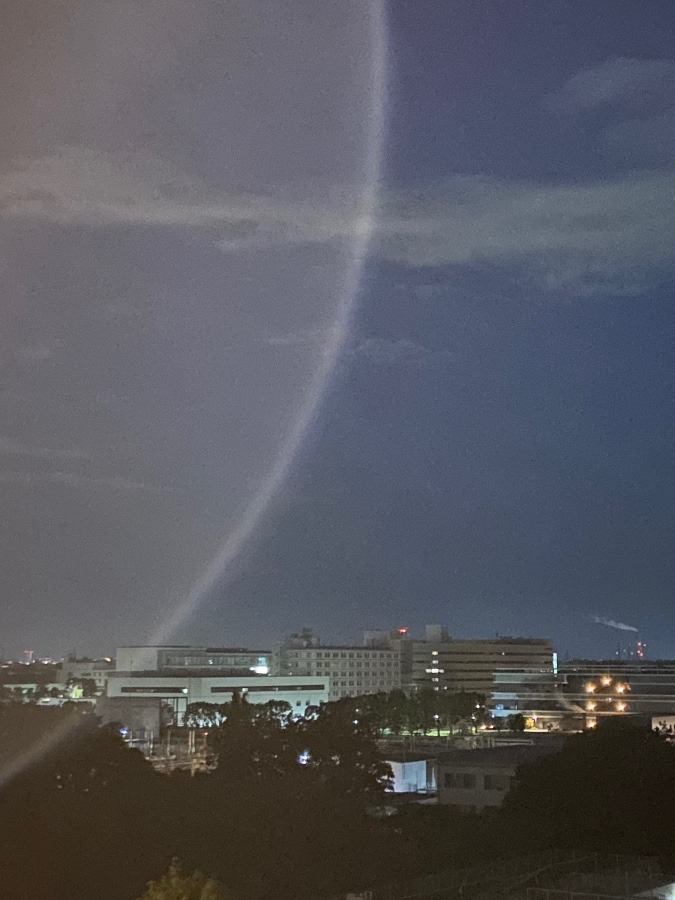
[438,736,562,812]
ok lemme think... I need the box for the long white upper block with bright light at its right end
[115,644,271,675]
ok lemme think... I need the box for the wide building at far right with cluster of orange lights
[491,659,675,730]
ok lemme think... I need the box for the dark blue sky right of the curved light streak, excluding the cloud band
[197,0,675,657]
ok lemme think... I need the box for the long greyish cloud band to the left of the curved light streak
[0,146,370,251]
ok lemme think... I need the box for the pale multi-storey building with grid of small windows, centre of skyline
[273,629,401,700]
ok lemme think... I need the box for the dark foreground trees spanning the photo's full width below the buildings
[0,698,675,900]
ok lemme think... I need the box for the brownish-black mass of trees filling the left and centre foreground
[0,701,398,900]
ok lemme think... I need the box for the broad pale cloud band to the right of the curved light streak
[377,171,675,295]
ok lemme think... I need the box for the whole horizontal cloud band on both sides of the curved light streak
[0,147,675,298]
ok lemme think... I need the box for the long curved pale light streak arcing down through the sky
[151,0,388,644]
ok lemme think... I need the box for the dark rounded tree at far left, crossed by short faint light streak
[0,703,161,900]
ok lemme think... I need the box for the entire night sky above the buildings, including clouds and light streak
[0,0,675,657]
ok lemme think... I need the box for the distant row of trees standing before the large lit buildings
[185,690,490,737]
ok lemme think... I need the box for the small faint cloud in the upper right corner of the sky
[546,57,675,113]
